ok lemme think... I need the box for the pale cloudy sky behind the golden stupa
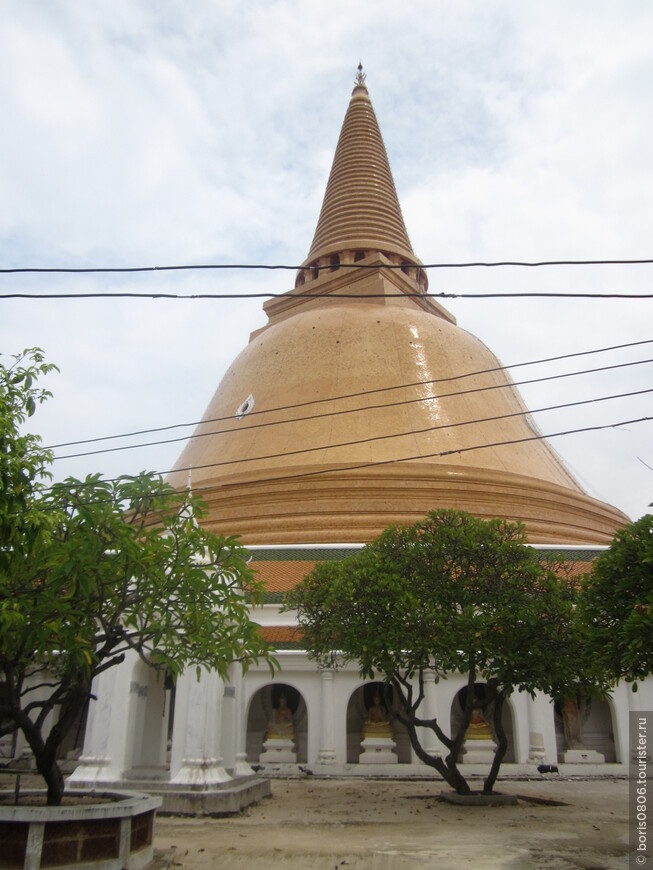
[0,0,653,519]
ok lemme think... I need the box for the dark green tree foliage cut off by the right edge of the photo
[579,514,653,688]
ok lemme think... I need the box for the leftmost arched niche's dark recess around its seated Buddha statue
[247,682,308,764]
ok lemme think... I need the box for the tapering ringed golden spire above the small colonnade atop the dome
[302,64,420,290]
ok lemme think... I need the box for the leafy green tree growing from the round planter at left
[0,351,276,804]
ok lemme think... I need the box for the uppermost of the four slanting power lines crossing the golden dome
[46,339,653,458]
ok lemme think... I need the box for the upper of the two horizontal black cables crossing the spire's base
[0,258,653,275]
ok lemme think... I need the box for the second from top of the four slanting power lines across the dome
[54,359,653,460]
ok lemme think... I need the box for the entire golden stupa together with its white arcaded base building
[67,67,640,812]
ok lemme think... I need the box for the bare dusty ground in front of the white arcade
[150,774,628,870]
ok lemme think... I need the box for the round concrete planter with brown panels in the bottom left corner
[0,790,161,870]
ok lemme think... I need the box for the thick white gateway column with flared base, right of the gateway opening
[170,668,231,786]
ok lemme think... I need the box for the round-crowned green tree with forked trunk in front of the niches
[285,510,579,794]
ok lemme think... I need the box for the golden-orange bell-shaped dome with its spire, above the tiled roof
[171,69,627,544]
